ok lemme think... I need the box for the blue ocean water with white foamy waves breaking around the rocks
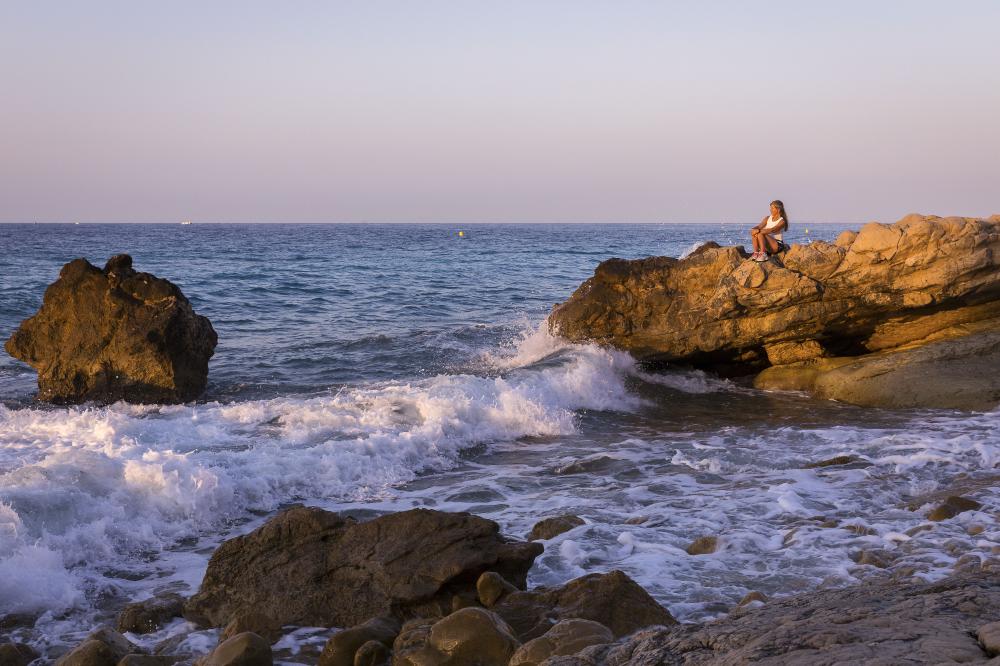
[0,224,1000,662]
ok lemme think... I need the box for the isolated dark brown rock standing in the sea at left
[5,254,218,403]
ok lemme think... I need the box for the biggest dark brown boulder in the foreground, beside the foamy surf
[184,506,542,627]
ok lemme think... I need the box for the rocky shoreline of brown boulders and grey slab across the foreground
[7,504,1000,666]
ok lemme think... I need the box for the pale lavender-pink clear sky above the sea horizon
[0,0,1000,223]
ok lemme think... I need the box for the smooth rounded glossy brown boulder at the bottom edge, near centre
[393,608,521,666]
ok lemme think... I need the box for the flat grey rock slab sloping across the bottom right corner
[546,573,1000,666]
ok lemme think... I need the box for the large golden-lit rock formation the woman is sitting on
[549,215,1000,409]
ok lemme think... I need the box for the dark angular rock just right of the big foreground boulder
[493,570,677,641]
